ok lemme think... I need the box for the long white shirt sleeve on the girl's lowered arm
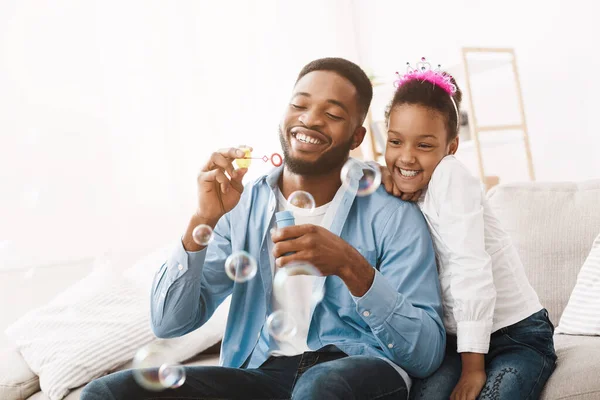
[428,159,496,353]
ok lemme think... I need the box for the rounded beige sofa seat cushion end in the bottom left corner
[0,348,40,400]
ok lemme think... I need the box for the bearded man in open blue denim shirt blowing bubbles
[82,58,445,400]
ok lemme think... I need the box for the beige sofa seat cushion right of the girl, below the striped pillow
[540,335,600,400]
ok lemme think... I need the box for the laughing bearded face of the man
[279,71,364,175]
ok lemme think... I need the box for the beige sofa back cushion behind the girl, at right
[488,180,600,325]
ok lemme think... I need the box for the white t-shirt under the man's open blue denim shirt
[270,190,335,356]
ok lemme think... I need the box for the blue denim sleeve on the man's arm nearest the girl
[354,203,446,378]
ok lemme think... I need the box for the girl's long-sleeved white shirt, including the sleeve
[418,156,542,353]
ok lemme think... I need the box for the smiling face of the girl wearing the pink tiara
[385,104,458,193]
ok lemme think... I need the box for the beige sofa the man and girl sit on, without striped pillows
[0,180,600,400]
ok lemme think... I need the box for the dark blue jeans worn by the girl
[410,309,556,400]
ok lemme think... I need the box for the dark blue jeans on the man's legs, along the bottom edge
[81,351,408,400]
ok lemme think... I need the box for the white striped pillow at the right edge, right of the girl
[556,235,600,336]
